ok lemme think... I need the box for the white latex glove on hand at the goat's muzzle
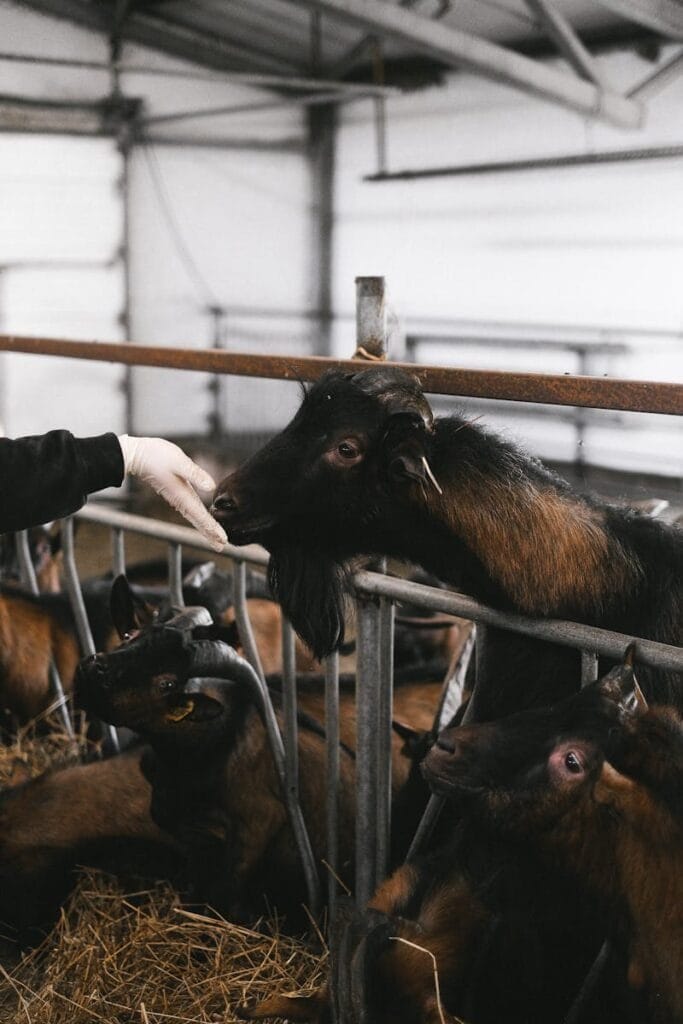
[119,434,227,551]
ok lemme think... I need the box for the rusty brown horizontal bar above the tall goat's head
[0,335,683,416]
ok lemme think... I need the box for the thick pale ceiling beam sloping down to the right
[293,0,642,128]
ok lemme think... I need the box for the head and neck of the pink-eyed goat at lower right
[425,655,683,1024]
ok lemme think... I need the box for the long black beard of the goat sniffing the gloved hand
[268,545,348,659]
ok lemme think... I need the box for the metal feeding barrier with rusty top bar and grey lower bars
[0,279,683,1019]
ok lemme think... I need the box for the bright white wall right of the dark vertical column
[335,48,683,475]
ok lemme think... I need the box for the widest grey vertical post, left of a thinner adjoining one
[355,598,380,907]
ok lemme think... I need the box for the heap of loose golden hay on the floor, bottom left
[0,872,326,1024]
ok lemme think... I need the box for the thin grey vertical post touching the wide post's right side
[377,598,394,882]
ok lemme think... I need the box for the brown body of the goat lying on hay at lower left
[0,748,179,945]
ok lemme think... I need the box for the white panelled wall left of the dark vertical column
[0,0,312,444]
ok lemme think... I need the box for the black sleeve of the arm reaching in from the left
[0,430,124,534]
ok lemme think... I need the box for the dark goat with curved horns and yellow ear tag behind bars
[78,578,440,920]
